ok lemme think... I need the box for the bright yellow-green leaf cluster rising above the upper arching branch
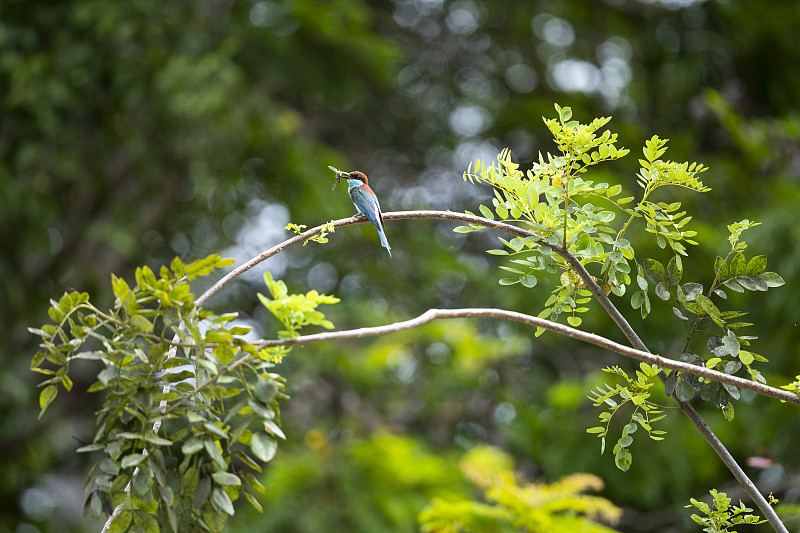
[455,105,709,334]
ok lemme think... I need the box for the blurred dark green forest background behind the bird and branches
[0,0,800,533]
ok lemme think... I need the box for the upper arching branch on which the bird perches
[188,211,786,532]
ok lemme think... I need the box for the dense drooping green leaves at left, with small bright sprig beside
[31,255,337,532]
